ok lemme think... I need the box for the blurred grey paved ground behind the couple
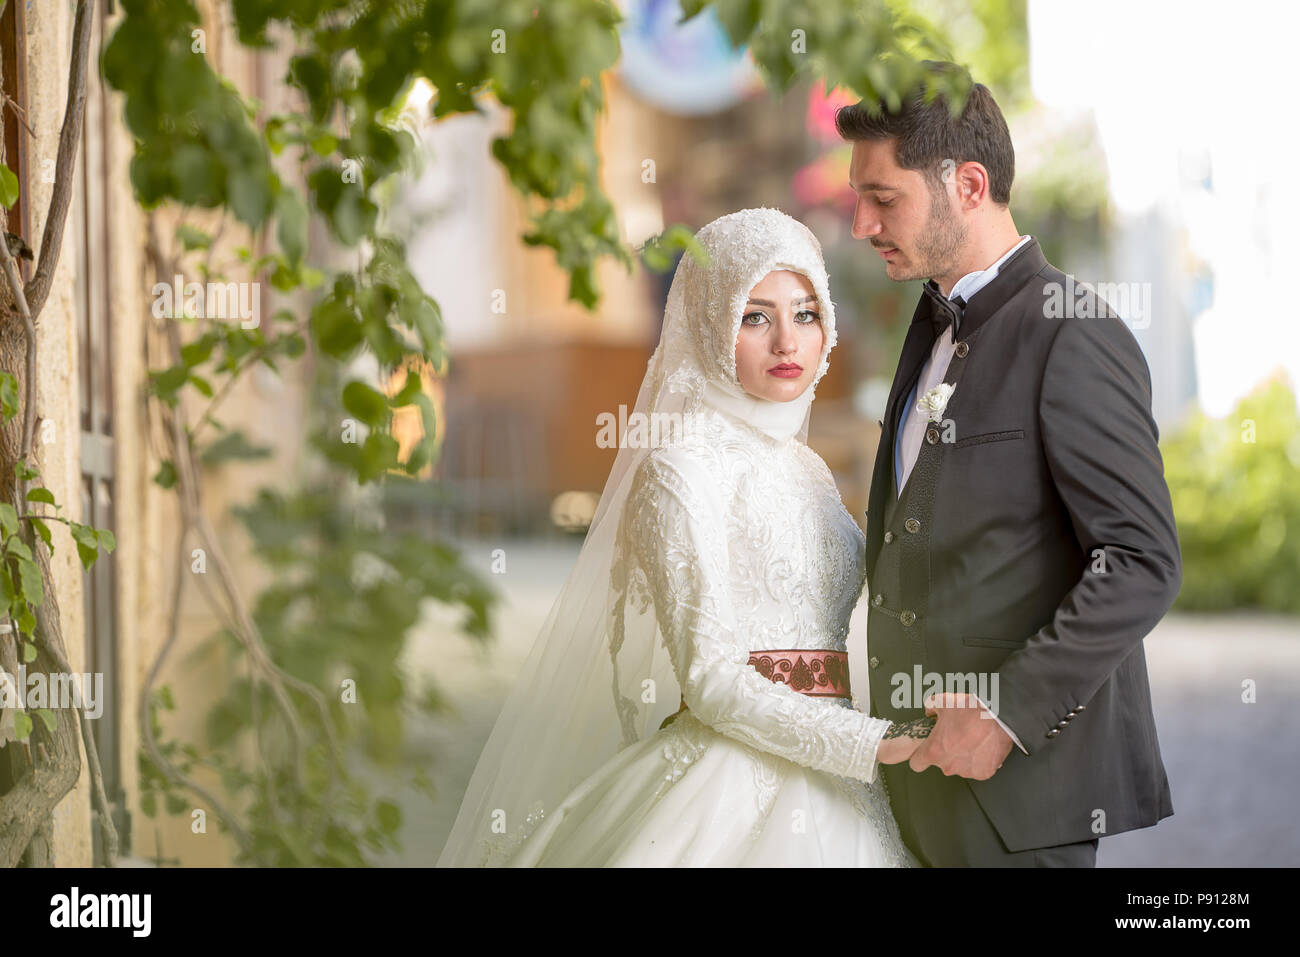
[369,541,1300,867]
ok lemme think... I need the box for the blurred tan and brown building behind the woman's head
[400,3,875,533]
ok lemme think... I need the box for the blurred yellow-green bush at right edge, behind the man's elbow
[1161,382,1300,614]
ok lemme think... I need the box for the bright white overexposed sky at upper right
[1028,0,1300,416]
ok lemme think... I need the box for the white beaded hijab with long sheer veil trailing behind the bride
[438,208,836,866]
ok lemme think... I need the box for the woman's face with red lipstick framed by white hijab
[736,269,826,402]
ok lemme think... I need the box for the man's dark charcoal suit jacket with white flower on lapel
[866,241,1182,850]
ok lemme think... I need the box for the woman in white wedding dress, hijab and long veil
[438,208,933,867]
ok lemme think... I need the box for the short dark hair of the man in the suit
[835,60,1015,205]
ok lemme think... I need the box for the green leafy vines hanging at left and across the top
[98,0,982,865]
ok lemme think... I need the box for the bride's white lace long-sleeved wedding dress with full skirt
[503,403,917,867]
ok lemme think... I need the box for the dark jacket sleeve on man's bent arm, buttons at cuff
[998,310,1182,754]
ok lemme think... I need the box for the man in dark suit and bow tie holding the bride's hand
[836,62,1182,867]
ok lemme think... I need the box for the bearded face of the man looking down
[849,139,966,282]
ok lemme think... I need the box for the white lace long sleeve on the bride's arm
[627,450,889,781]
